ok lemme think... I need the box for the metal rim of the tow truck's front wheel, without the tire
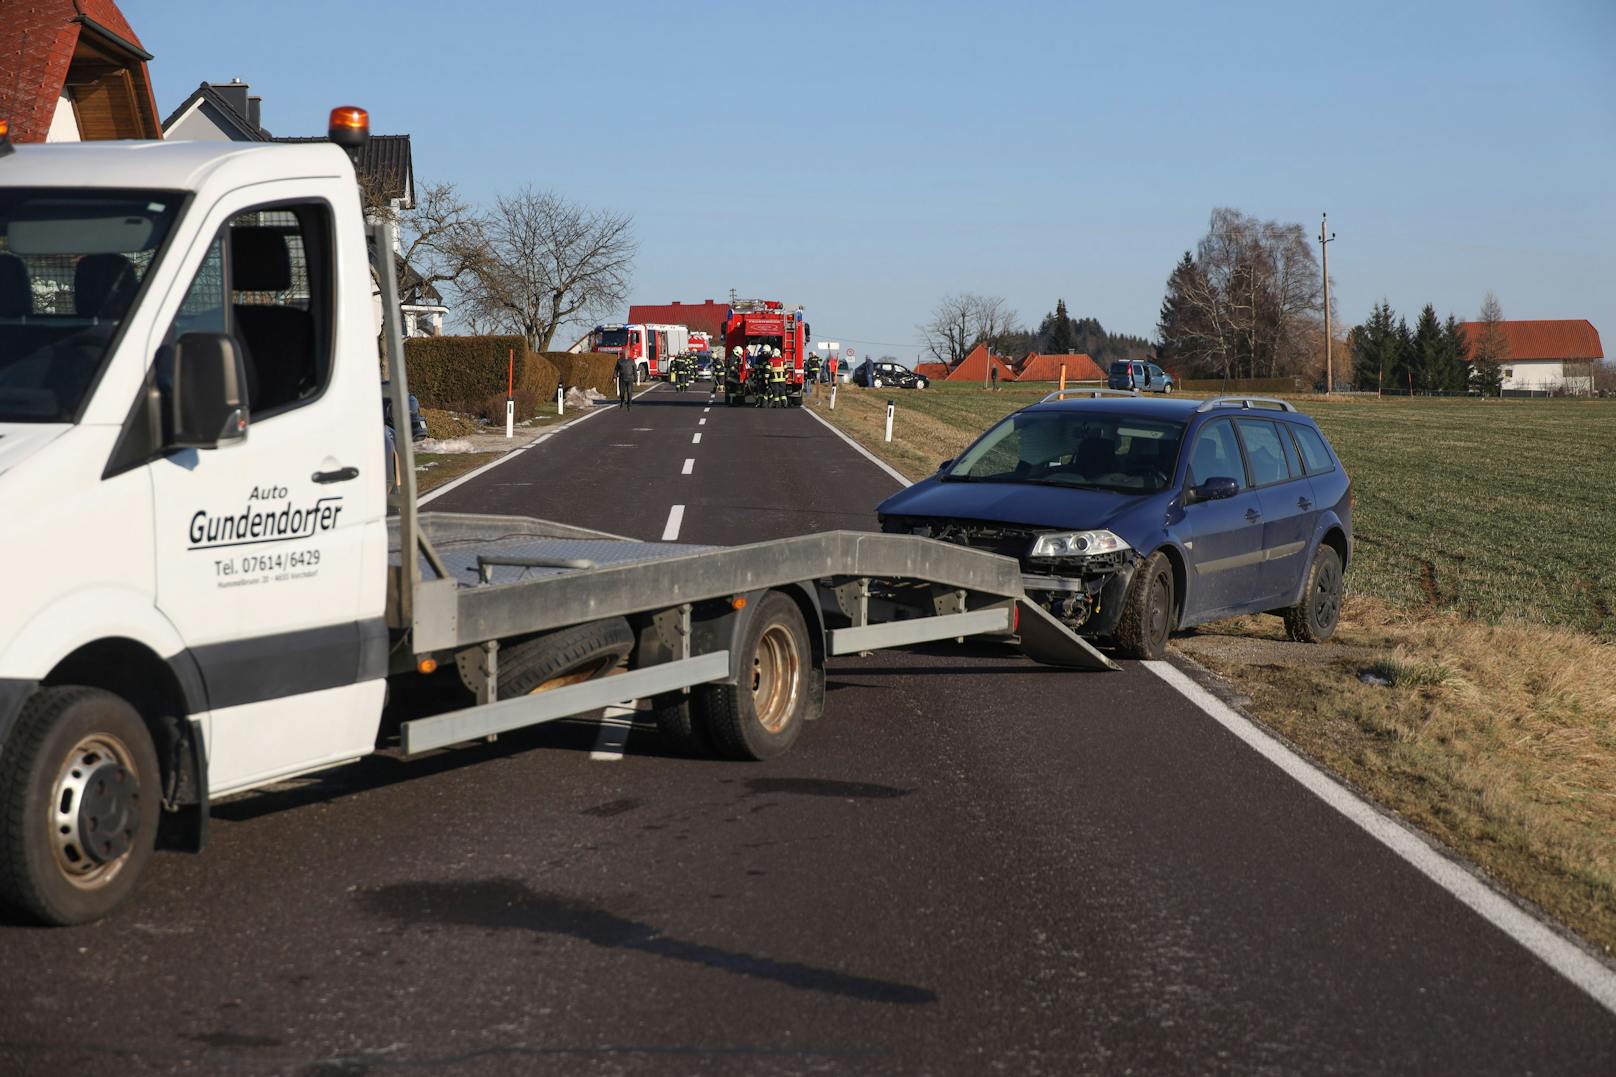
[50,733,141,889]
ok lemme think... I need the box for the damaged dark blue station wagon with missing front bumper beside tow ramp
[877,393,1353,658]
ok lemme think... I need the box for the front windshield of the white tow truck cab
[0,188,181,422]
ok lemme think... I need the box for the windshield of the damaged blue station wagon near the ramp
[944,408,1185,493]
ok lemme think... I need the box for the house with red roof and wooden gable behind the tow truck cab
[0,0,162,142]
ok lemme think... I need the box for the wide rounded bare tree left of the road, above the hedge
[461,186,637,351]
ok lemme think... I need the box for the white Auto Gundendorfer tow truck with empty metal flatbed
[0,108,1110,923]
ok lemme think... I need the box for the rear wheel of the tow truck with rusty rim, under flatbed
[695,590,813,760]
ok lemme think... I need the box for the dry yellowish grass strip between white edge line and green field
[1196,597,1616,952]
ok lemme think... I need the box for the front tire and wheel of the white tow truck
[0,687,162,925]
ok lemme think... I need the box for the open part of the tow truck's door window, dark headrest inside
[226,204,333,420]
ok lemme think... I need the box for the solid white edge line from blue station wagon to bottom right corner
[1139,661,1616,1014]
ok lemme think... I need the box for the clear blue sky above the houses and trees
[135,0,1616,361]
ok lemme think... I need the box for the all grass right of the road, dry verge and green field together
[813,385,1616,954]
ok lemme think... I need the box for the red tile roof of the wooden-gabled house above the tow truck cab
[0,0,160,142]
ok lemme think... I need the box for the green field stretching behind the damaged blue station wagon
[814,385,1616,639]
